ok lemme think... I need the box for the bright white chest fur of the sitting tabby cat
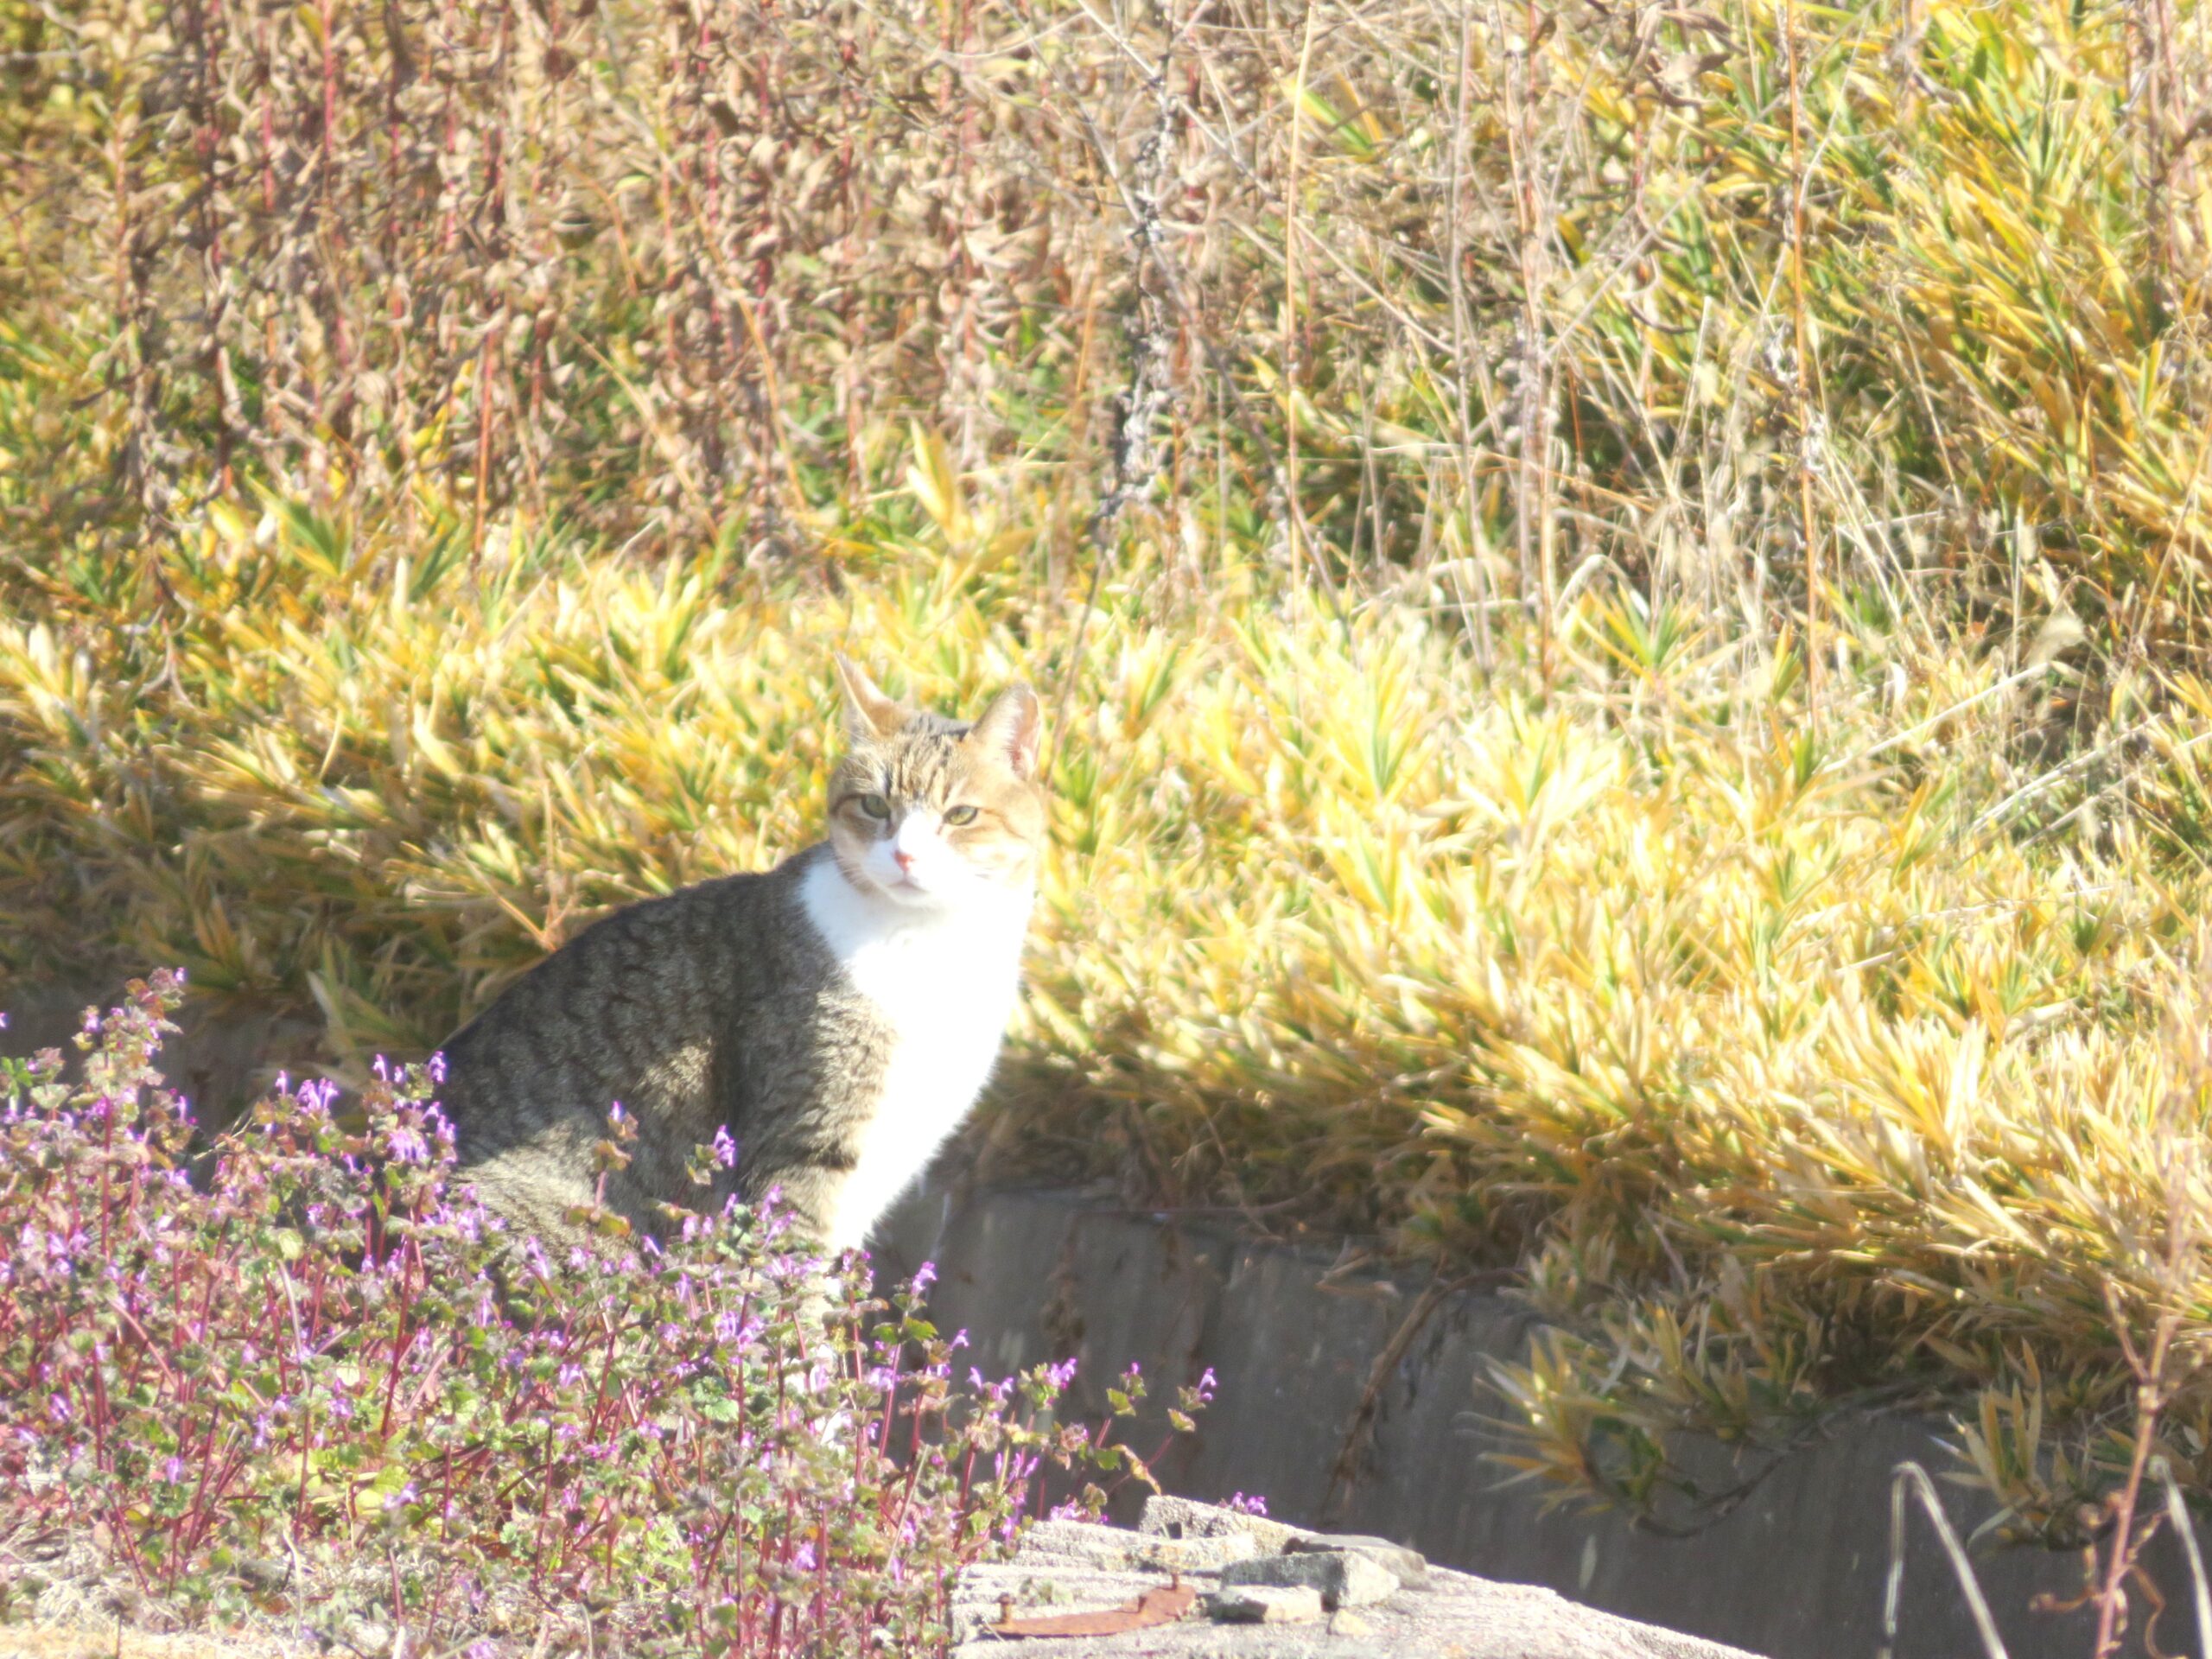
[798,858,1031,1249]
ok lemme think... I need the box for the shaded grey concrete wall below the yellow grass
[876,1188,2177,1659]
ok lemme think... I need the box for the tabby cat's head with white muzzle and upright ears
[830,657,1044,909]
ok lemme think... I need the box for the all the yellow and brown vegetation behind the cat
[17,0,2212,1628]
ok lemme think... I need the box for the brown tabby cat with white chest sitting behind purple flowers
[440,657,1046,1252]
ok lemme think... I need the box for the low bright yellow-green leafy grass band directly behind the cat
[0,471,2212,1513]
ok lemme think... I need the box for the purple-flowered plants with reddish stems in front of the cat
[0,976,1192,1659]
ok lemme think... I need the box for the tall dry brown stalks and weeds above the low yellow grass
[13,0,2212,619]
